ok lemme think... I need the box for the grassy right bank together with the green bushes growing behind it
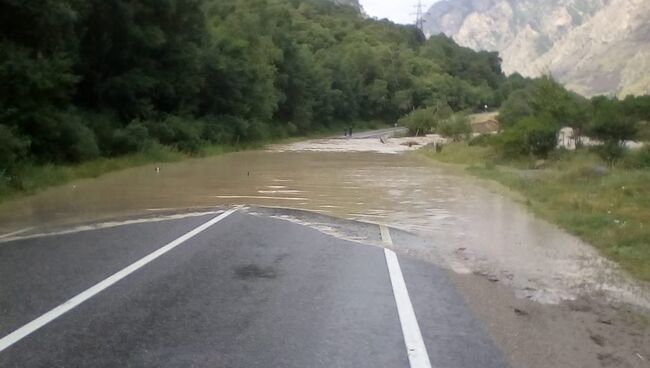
[425,77,650,280]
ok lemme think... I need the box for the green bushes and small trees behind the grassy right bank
[492,76,650,162]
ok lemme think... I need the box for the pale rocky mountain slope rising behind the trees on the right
[425,0,650,96]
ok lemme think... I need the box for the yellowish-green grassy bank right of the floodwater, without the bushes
[422,143,650,281]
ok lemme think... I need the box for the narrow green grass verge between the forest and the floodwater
[0,121,389,203]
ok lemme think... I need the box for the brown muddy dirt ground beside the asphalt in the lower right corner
[451,273,650,368]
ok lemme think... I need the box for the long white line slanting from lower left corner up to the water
[0,207,240,352]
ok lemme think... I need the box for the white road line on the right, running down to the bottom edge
[379,225,431,368]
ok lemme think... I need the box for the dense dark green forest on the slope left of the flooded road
[0,0,508,176]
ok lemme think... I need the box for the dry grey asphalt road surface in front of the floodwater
[0,210,506,368]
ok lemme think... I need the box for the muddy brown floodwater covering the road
[0,134,650,306]
